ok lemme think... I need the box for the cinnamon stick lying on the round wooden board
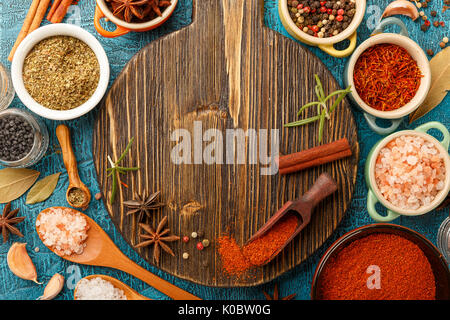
[278,138,351,171]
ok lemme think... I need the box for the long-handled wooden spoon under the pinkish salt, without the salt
[36,207,200,300]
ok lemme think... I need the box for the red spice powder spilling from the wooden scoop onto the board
[217,214,298,276]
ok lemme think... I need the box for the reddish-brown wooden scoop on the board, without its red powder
[246,173,337,264]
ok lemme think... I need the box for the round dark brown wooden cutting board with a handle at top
[93,0,359,287]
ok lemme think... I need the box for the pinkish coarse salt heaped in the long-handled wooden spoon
[36,208,89,256]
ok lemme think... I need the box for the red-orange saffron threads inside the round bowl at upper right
[353,43,423,111]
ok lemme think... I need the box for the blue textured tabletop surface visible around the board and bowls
[0,0,450,299]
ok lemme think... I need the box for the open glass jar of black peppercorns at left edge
[0,108,48,168]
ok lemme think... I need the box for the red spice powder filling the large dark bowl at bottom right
[318,233,436,300]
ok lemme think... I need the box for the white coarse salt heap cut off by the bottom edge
[75,277,127,300]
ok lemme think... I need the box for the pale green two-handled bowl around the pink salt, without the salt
[365,121,450,222]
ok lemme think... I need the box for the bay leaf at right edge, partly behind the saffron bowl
[409,47,450,123]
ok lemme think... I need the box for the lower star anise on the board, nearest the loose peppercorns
[135,216,180,264]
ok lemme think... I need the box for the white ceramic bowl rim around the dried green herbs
[11,23,110,120]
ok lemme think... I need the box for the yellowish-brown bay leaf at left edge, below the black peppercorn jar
[0,168,40,203]
